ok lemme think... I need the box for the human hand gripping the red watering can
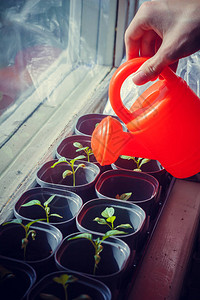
[125,0,200,85]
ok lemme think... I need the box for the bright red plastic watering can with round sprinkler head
[91,58,200,178]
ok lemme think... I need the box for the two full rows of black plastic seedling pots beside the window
[0,115,169,299]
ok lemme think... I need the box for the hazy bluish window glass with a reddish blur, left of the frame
[0,0,69,115]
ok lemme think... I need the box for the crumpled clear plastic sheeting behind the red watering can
[104,51,200,115]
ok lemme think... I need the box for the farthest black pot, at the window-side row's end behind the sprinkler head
[74,114,127,136]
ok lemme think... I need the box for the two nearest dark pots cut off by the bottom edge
[0,256,111,300]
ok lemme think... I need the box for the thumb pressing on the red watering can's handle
[132,50,171,85]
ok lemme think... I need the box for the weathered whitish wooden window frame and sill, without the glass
[0,0,135,223]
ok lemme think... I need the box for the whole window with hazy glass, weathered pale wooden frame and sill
[0,0,137,221]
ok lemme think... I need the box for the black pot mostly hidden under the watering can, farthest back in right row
[111,157,166,185]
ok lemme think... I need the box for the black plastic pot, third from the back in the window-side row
[36,160,100,202]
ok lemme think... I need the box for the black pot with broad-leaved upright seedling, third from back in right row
[76,198,146,256]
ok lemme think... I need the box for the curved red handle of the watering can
[109,57,178,124]
